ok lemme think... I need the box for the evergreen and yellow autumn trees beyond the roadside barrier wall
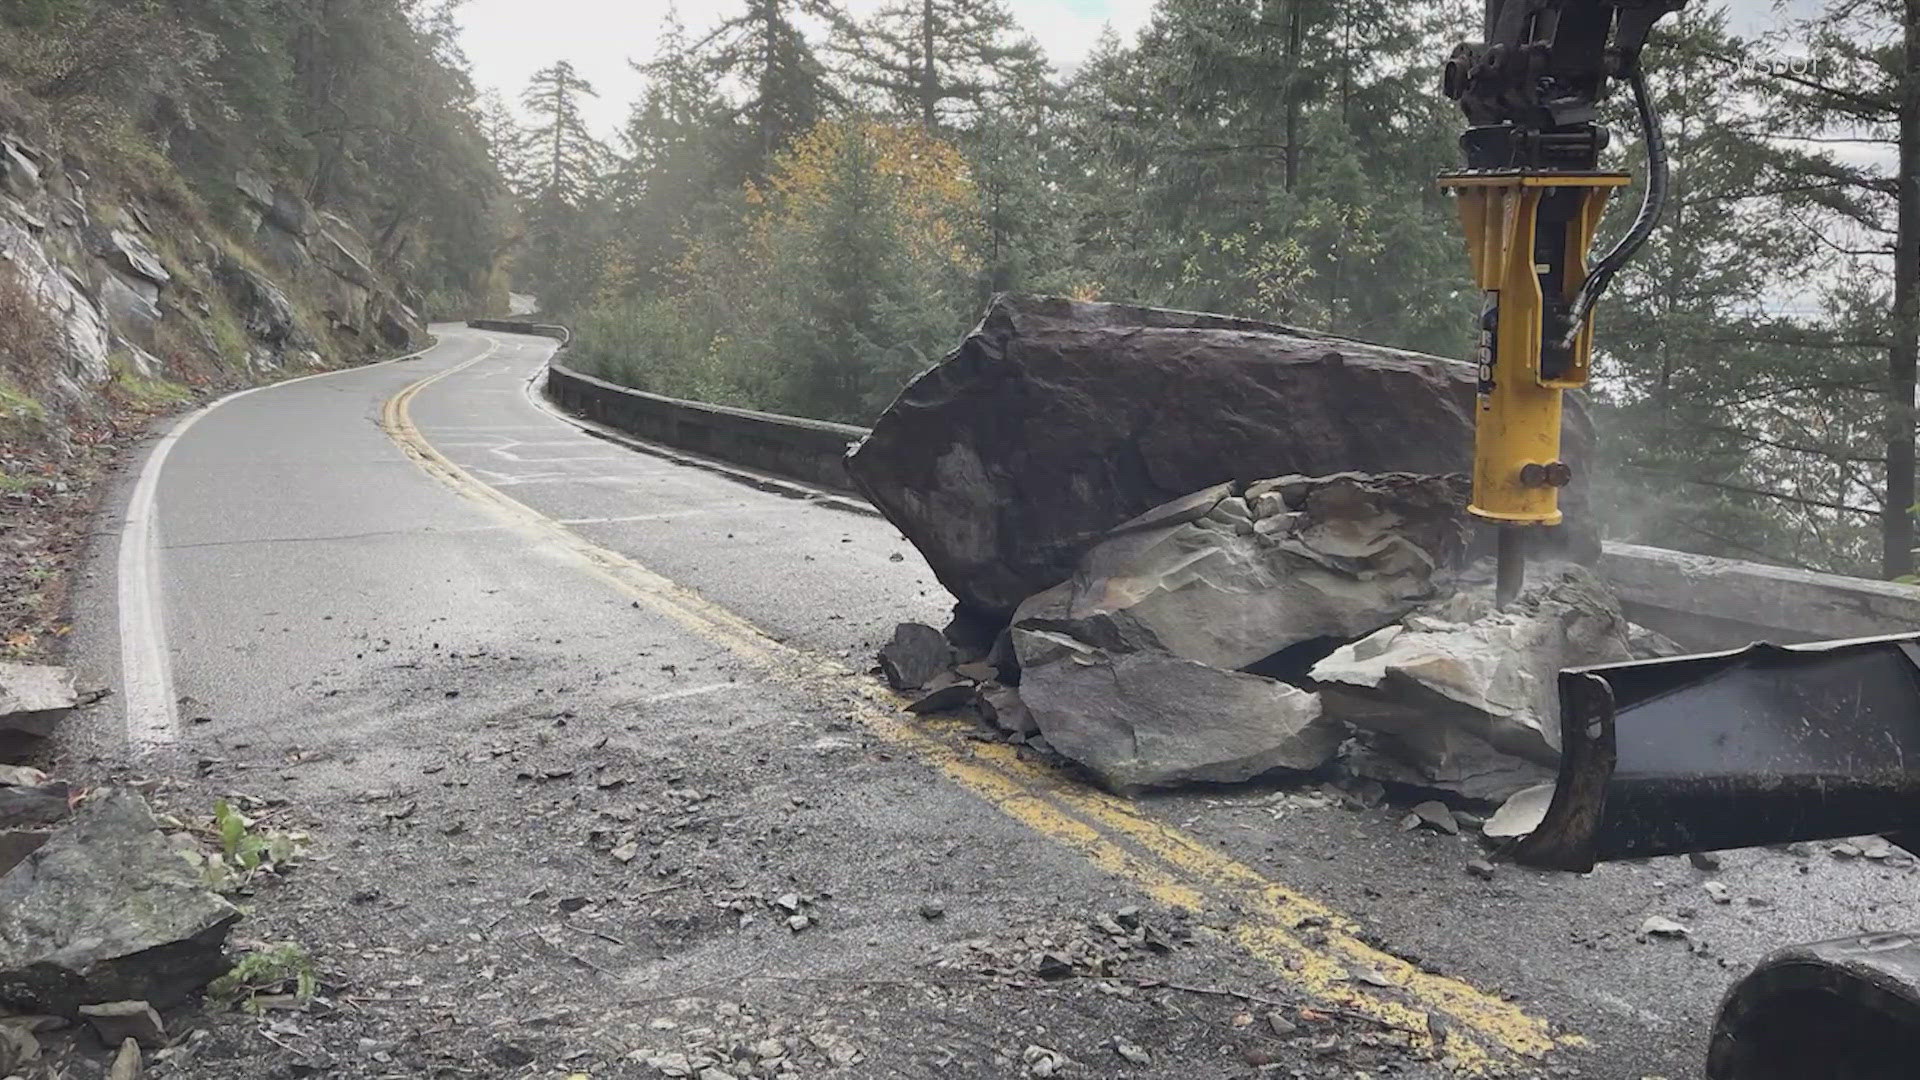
[488,0,1920,577]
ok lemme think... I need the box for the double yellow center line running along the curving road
[382,350,1584,1076]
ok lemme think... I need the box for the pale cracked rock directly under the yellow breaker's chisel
[1309,565,1630,801]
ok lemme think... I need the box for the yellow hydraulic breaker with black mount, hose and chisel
[1440,0,1686,605]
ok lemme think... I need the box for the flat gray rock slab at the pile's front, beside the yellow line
[1014,630,1344,790]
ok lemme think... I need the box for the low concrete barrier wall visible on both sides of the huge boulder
[547,353,1920,650]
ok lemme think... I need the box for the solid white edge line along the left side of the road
[117,338,440,753]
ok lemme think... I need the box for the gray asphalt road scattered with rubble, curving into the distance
[71,327,1920,1078]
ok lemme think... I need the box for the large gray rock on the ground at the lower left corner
[0,788,240,1017]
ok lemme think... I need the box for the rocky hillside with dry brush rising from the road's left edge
[0,92,426,659]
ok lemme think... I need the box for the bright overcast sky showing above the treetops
[459,0,1816,135]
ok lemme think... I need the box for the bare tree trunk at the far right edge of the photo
[1880,0,1920,578]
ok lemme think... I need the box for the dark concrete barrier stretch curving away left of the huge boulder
[547,363,866,492]
